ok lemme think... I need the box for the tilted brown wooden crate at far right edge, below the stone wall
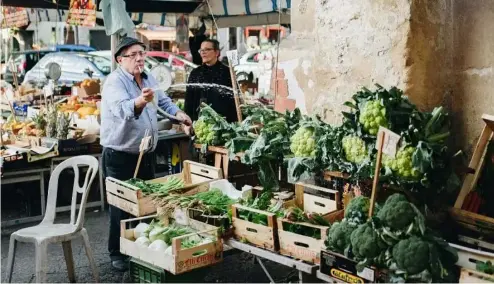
[450,114,494,236]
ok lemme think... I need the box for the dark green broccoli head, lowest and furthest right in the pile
[393,236,434,275]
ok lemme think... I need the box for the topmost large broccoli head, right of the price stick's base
[377,193,416,230]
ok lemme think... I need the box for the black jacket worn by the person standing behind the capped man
[185,61,237,122]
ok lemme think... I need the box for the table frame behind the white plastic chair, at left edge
[1,167,50,228]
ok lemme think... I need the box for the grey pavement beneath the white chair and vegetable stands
[1,210,312,283]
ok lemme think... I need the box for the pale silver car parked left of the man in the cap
[23,52,111,86]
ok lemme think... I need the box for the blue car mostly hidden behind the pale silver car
[2,44,96,84]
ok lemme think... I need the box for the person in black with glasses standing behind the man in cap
[185,39,237,132]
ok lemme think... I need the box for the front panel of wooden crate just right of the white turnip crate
[232,204,279,251]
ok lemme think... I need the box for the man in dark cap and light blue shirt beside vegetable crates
[100,37,191,271]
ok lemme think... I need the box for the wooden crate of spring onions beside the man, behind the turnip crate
[106,161,223,217]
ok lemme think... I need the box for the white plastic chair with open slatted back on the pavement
[7,156,99,283]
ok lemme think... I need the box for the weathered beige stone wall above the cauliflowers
[278,0,494,153]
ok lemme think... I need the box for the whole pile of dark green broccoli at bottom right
[326,193,458,282]
